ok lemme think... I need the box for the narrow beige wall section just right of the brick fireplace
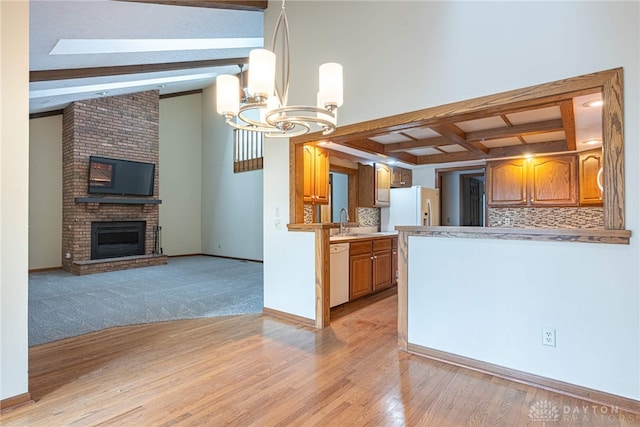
[160,94,202,255]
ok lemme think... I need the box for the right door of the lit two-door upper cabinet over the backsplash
[529,155,578,206]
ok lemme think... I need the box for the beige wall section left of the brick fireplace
[29,114,62,270]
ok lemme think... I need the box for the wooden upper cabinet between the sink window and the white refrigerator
[358,163,391,208]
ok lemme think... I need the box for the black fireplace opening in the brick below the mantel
[91,221,146,259]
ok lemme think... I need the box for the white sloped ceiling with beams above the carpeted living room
[29,0,264,113]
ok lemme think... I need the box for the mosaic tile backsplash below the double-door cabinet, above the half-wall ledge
[487,206,604,229]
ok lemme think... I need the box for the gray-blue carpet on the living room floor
[29,256,263,346]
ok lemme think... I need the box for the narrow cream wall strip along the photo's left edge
[0,1,29,400]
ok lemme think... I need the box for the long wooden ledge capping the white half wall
[396,226,631,245]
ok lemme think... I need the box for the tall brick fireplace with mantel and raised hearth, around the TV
[62,91,167,274]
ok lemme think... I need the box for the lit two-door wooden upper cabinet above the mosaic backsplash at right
[487,154,578,206]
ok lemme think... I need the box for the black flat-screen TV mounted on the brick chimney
[89,156,156,196]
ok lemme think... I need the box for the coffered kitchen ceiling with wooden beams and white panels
[324,93,602,166]
